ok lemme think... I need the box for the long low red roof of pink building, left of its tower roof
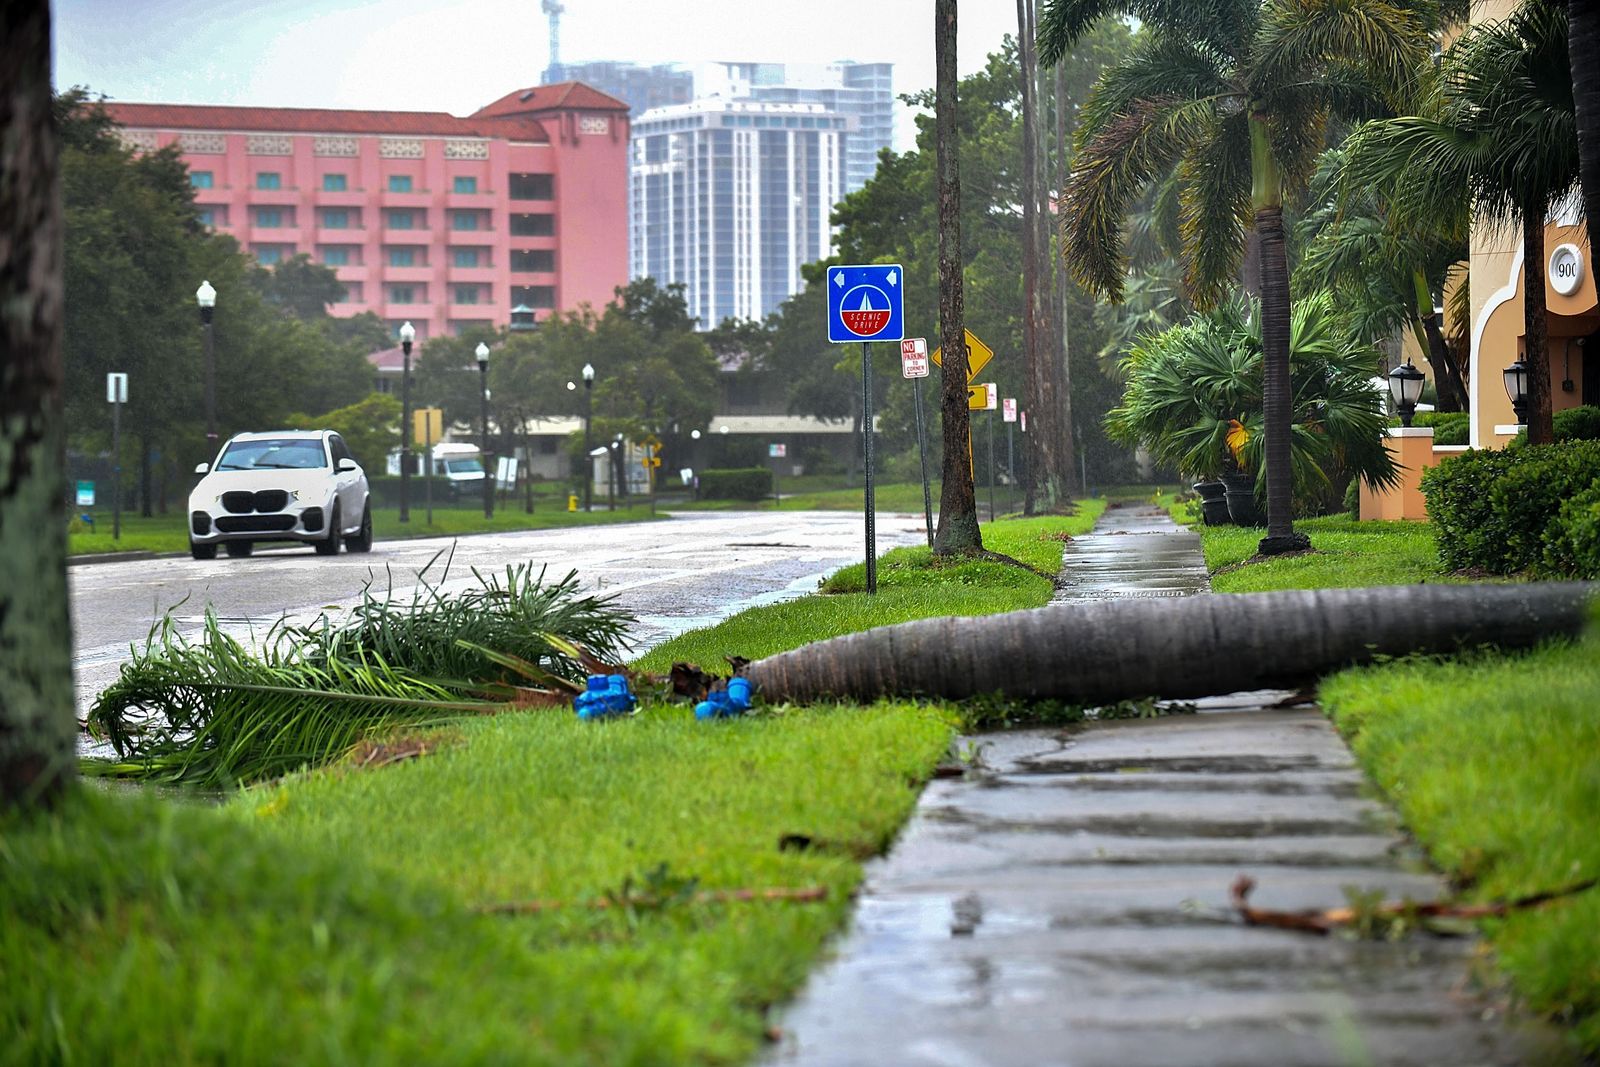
[106,98,550,144]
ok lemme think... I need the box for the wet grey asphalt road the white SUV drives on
[69,512,923,726]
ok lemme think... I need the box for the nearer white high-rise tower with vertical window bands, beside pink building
[629,96,856,328]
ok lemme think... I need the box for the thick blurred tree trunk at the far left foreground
[0,0,77,808]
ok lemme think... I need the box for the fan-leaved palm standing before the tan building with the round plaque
[1346,3,1579,443]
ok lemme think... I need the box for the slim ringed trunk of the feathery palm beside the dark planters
[1250,109,1310,555]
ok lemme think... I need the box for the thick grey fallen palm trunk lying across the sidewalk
[744,582,1597,705]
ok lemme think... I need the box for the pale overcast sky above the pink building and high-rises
[53,0,1016,152]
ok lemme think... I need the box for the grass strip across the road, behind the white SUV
[67,498,666,555]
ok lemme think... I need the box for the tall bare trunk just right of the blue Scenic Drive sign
[933,0,984,555]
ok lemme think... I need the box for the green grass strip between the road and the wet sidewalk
[12,504,1099,1064]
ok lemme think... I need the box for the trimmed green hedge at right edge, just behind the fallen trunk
[1422,442,1600,577]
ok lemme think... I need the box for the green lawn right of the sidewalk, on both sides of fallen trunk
[1168,499,1600,1057]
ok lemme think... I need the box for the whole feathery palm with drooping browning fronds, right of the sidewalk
[1038,0,1429,553]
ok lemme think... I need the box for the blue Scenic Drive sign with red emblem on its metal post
[827,262,906,595]
